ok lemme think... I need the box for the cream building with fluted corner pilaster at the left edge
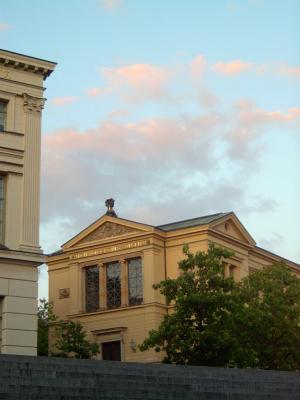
[0,50,56,355]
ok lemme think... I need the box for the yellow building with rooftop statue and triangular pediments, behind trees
[48,199,300,362]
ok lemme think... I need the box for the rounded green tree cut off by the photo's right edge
[232,262,300,370]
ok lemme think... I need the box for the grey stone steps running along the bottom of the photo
[0,355,300,400]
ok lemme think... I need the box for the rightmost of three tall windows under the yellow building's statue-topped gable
[128,258,143,306]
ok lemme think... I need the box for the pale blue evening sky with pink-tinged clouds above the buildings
[0,0,300,297]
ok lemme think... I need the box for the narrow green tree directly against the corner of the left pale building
[37,299,57,356]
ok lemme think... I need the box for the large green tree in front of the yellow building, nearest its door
[140,244,236,365]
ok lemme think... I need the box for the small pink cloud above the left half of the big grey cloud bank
[101,64,172,100]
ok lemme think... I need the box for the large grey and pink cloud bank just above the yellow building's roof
[41,95,300,253]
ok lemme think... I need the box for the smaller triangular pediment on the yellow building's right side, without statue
[210,213,255,245]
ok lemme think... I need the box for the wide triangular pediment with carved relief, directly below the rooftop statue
[62,215,153,249]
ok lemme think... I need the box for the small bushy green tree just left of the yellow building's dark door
[53,321,99,358]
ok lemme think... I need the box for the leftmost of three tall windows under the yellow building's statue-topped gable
[85,265,99,312]
